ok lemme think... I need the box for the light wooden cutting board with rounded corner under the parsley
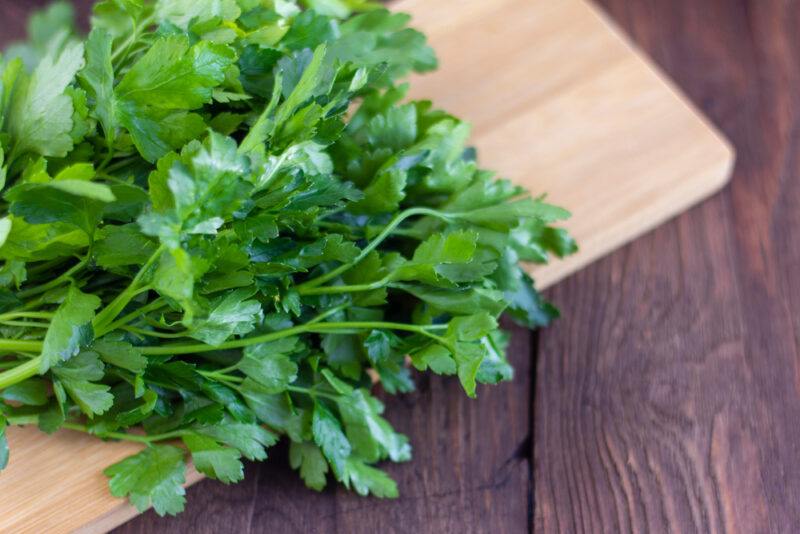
[0,0,734,534]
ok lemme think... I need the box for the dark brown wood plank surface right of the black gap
[533,0,800,533]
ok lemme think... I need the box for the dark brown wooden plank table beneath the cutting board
[0,0,800,534]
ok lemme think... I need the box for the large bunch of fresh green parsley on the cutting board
[0,0,575,514]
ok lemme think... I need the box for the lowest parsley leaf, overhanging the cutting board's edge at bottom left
[103,445,186,516]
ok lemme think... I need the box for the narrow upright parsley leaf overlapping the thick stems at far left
[39,287,100,374]
